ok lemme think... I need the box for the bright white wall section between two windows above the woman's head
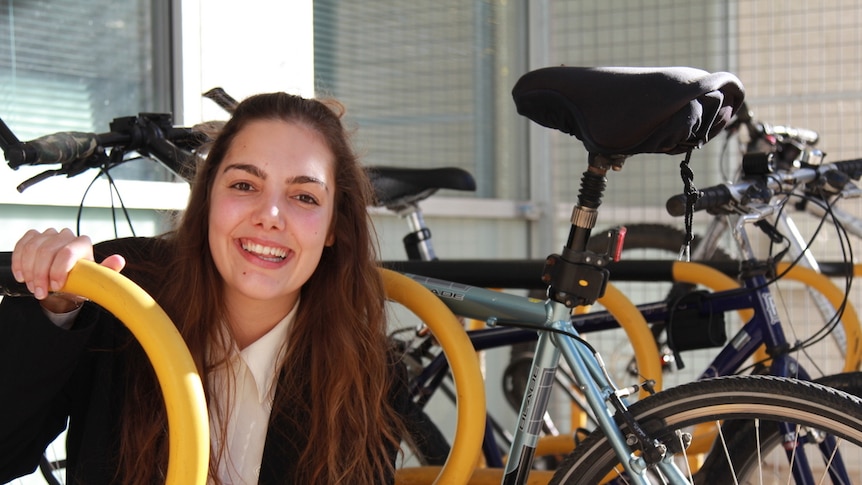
[176,0,314,124]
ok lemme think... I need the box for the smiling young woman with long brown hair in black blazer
[0,93,409,484]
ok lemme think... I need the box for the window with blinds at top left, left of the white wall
[0,0,172,180]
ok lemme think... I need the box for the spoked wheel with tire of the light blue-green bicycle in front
[551,376,862,484]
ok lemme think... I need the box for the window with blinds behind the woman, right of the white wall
[314,0,527,199]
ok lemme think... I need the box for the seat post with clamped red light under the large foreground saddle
[542,153,626,308]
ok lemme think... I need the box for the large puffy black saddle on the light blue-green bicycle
[512,66,745,156]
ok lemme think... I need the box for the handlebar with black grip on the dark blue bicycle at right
[665,159,862,217]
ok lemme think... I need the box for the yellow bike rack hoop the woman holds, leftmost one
[62,261,210,485]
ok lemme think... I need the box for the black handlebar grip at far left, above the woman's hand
[5,131,99,169]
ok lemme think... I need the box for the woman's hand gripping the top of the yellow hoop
[12,229,126,313]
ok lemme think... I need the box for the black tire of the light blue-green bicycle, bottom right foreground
[550,376,862,485]
